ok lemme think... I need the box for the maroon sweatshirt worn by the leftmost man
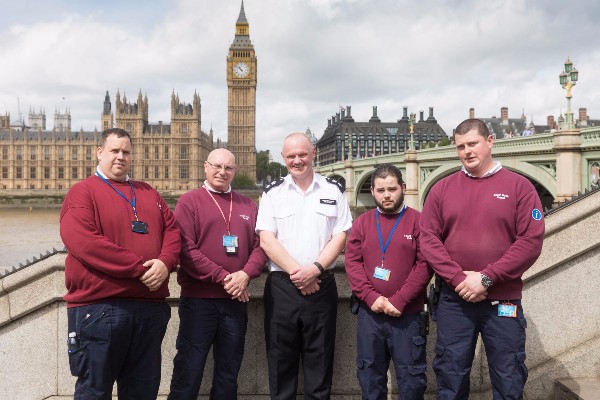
[60,176,180,307]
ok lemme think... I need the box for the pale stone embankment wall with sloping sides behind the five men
[0,192,600,400]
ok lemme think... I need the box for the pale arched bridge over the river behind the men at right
[316,126,600,209]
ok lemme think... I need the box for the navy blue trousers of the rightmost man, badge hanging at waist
[433,285,527,400]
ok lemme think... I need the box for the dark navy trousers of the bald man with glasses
[169,297,248,400]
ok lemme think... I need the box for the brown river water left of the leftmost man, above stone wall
[0,208,64,272]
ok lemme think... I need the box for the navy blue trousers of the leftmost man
[67,299,171,400]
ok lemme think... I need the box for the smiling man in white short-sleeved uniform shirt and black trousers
[256,133,352,400]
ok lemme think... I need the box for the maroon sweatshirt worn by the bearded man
[346,207,433,313]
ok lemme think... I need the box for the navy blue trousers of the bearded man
[356,302,427,400]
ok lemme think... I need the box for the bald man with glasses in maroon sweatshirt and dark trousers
[169,149,267,400]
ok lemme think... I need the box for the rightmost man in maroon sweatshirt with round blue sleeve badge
[421,119,544,400]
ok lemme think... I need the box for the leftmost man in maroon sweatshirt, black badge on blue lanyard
[60,128,181,400]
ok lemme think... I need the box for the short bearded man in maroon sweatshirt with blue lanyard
[346,164,433,400]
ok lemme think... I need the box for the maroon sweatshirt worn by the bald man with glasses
[175,187,267,298]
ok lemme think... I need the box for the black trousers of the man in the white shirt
[264,271,338,400]
